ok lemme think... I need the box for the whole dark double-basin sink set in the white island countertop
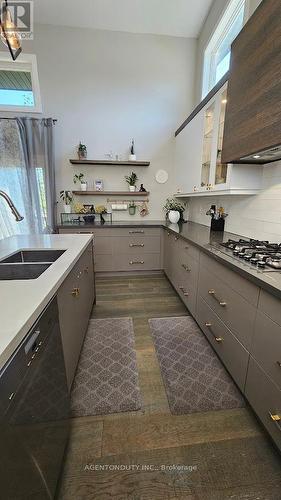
[0,250,65,281]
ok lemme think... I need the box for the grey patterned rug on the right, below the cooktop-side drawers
[149,316,245,414]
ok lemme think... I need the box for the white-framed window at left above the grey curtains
[0,53,42,113]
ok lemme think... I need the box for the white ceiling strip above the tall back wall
[34,0,212,38]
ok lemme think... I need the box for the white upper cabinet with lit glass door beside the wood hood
[175,83,262,197]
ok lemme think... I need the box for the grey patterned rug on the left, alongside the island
[71,318,141,417]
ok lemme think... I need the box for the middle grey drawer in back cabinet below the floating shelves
[114,235,161,256]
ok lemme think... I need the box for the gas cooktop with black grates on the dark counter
[220,239,281,272]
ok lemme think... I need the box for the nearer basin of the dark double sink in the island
[0,262,52,280]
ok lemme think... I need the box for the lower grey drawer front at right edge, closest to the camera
[245,357,281,451]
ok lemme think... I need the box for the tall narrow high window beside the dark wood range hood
[202,0,245,98]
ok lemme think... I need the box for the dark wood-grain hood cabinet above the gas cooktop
[222,0,281,163]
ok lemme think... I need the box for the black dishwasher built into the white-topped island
[0,298,70,500]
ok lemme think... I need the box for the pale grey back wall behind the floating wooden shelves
[24,25,196,220]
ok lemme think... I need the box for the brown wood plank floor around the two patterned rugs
[59,275,281,500]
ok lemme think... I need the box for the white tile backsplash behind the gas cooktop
[188,161,281,242]
